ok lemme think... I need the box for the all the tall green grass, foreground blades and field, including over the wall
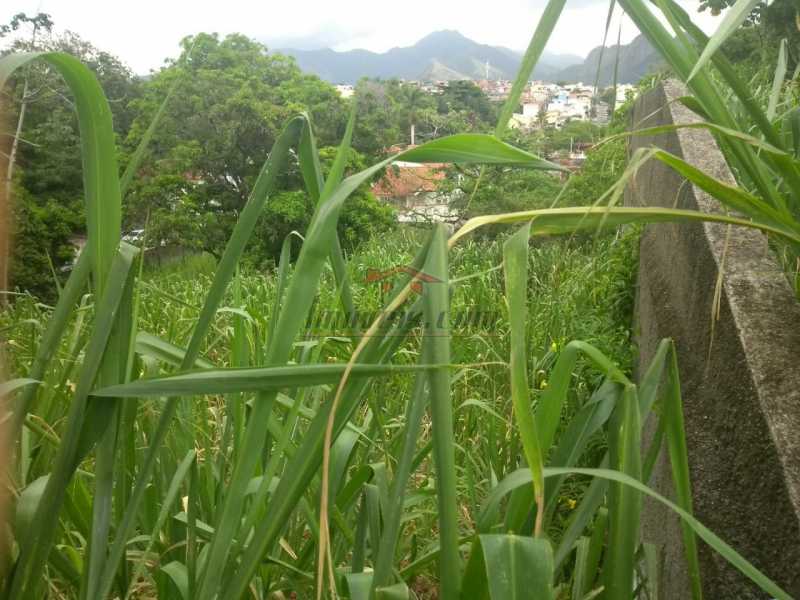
[0,0,800,600]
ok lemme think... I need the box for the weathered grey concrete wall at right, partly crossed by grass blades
[625,82,800,600]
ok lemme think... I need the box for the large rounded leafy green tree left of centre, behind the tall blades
[126,33,347,255]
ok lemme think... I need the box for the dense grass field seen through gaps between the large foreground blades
[2,229,637,597]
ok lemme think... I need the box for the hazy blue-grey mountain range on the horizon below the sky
[279,30,658,85]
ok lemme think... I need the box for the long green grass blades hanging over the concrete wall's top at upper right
[608,0,800,295]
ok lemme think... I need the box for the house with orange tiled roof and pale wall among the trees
[372,161,457,223]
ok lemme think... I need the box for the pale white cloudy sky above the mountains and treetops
[0,0,719,74]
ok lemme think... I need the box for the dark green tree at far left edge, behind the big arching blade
[0,13,139,297]
